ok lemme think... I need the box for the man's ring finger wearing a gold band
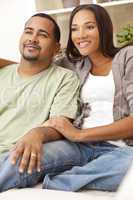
[28,151,38,174]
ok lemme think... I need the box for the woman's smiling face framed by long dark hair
[71,10,99,56]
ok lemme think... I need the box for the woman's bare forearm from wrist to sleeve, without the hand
[77,117,133,142]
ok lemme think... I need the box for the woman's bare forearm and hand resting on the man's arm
[44,117,133,142]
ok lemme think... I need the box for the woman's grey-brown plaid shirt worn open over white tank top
[56,46,133,146]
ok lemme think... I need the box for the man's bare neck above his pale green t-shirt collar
[18,59,51,77]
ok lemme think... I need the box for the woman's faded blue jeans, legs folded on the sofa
[43,142,133,191]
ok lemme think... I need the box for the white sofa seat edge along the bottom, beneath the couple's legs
[0,187,115,200]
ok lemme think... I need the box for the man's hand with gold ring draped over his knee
[11,127,44,174]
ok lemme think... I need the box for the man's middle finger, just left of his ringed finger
[19,148,30,173]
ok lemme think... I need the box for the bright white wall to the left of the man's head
[0,0,35,61]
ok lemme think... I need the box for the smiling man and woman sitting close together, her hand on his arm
[0,4,133,192]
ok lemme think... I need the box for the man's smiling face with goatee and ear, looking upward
[20,16,59,63]
